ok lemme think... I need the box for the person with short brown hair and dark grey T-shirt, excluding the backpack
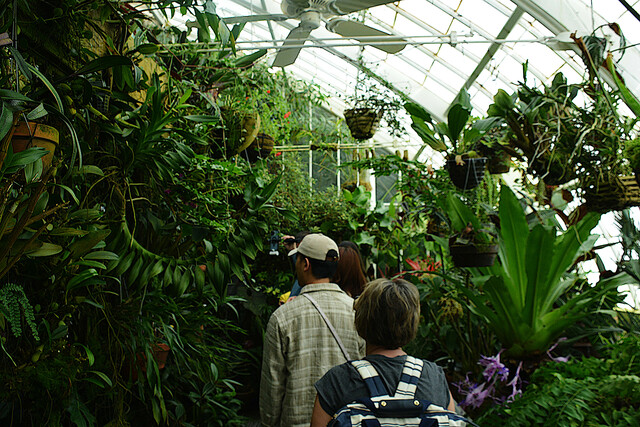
[311,279,455,427]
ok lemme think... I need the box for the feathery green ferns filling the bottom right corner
[476,335,640,427]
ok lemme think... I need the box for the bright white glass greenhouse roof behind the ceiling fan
[161,0,640,159]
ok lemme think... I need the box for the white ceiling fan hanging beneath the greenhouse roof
[223,0,406,67]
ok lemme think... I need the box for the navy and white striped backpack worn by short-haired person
[328,356,476,427]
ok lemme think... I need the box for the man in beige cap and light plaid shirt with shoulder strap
[260,234,365,427]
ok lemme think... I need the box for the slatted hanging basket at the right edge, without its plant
[584,176,640,213]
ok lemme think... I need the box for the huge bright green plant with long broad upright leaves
[461,186,624,357]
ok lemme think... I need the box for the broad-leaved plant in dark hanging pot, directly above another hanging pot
[405,91,499,190]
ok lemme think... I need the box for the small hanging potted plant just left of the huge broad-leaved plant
[447,194,498,267]
